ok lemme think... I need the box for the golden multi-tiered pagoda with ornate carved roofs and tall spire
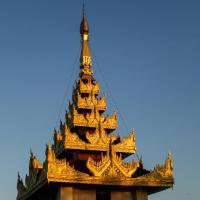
[17,9,174,200]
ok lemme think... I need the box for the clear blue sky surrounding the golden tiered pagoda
[0,0,200,200]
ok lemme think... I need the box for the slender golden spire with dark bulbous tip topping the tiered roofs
[80,4,92,74]
